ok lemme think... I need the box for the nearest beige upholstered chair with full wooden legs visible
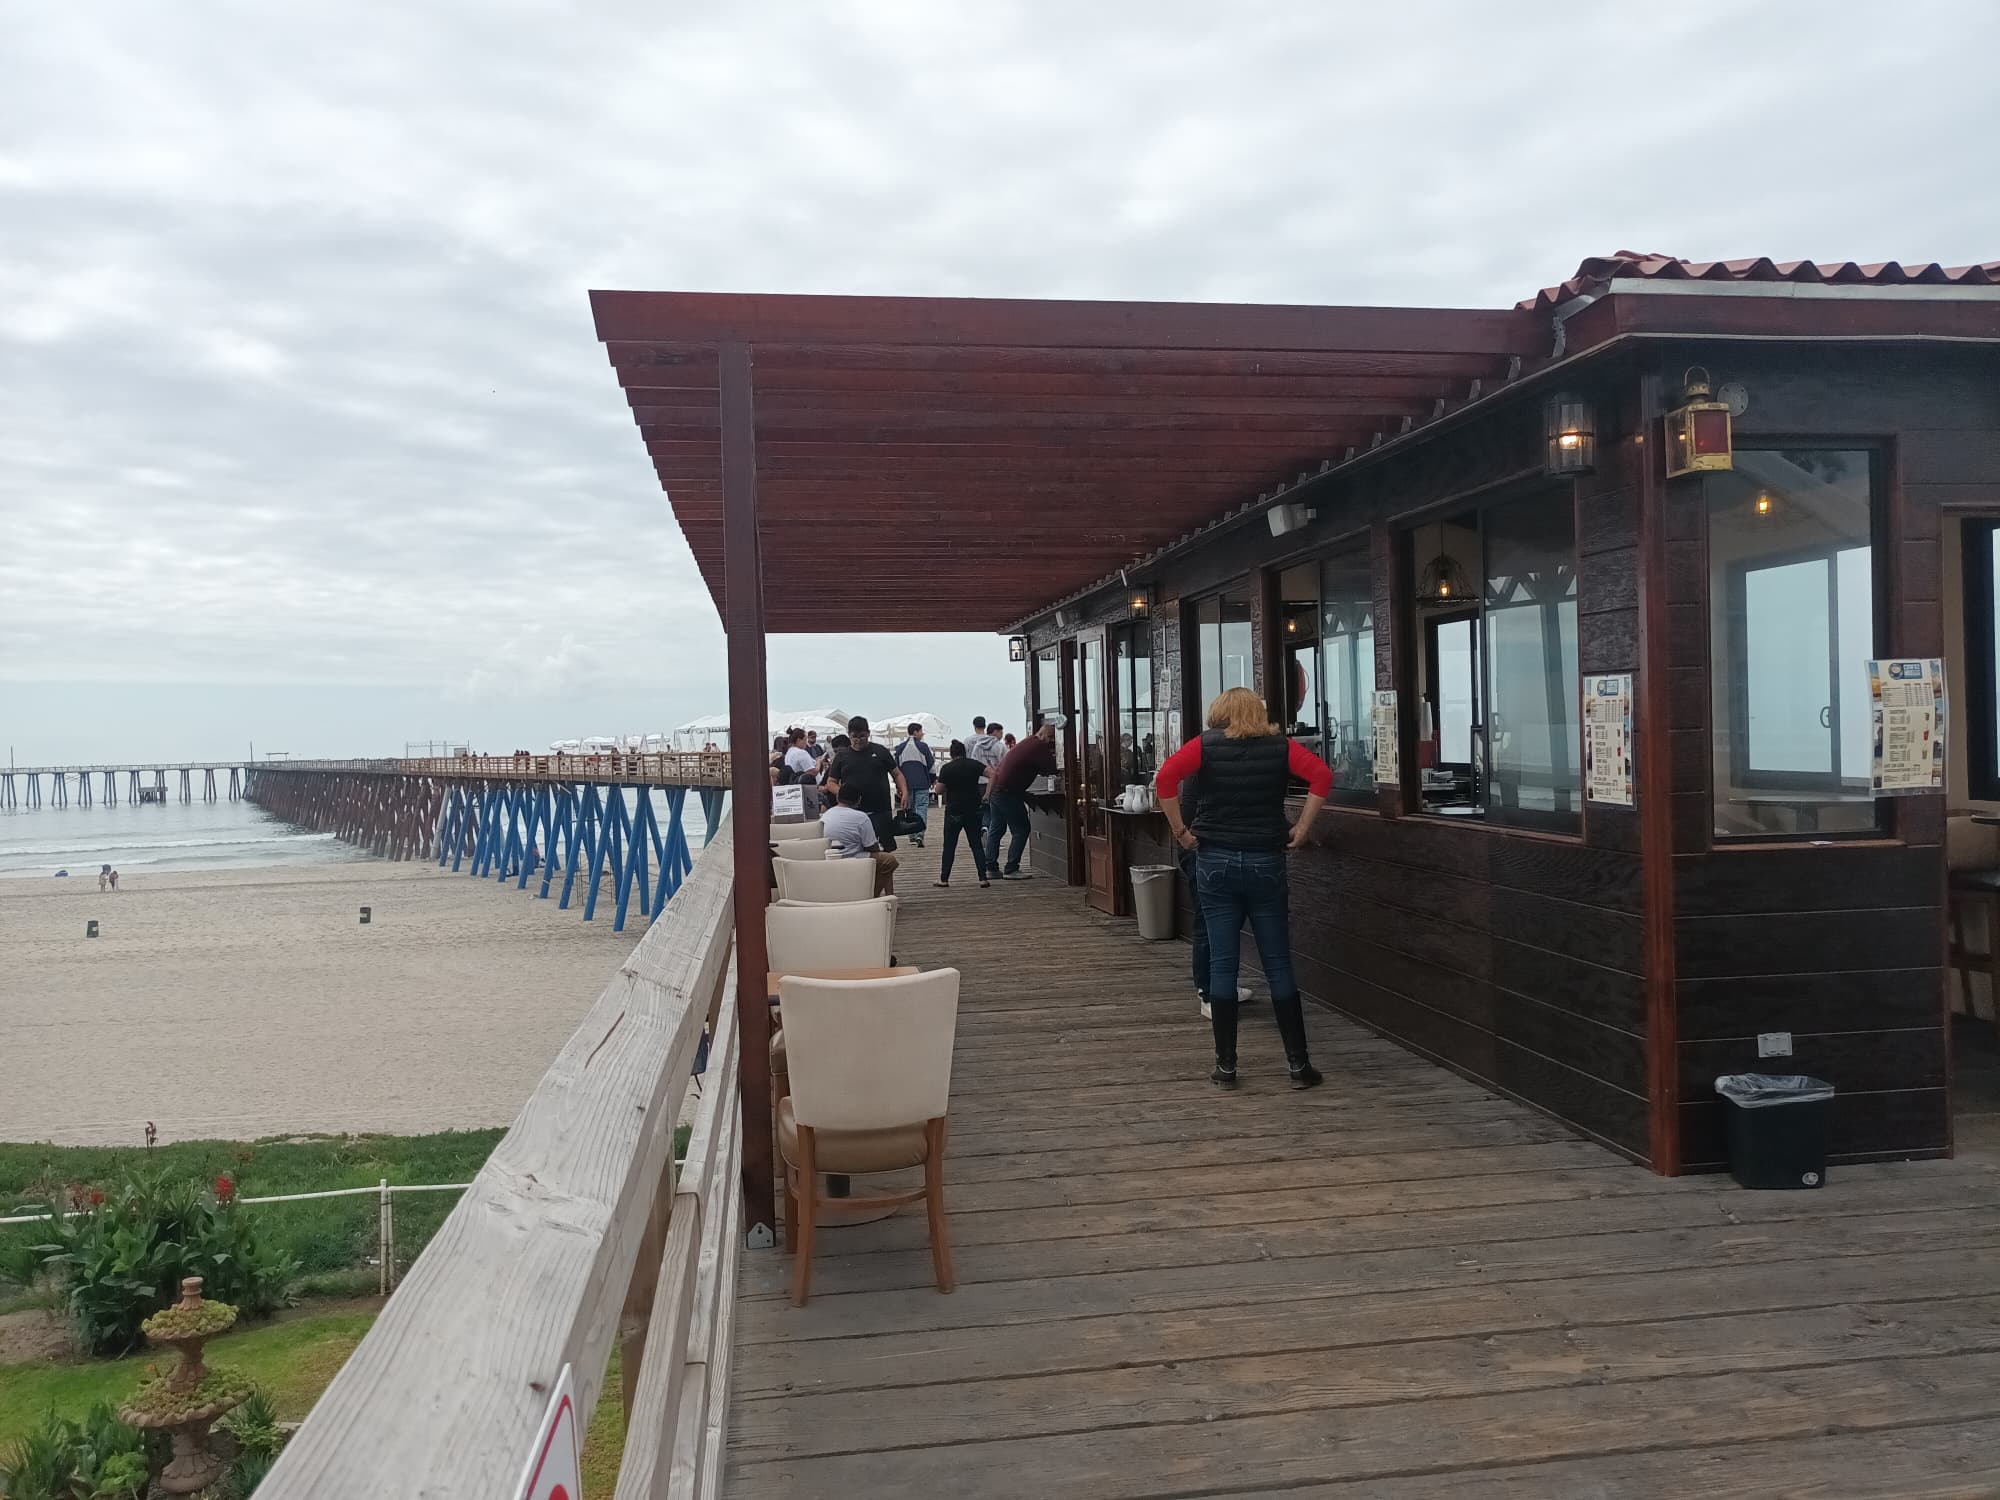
[778,968,958,1306]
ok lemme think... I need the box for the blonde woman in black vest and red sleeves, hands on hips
[1154,688,1334,1088]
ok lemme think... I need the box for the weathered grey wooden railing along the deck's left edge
[258,828,742,1500]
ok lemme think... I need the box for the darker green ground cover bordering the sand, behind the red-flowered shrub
[0,1130,504,1304]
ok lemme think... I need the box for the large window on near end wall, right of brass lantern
[1708,448,1876,838]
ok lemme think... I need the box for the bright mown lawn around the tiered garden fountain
[0,1312,624,1494]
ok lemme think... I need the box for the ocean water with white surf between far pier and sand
[0,800,368,880]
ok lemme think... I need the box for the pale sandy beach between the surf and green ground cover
[0,862,644,1146]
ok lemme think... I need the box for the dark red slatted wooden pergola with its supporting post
[590,292,1550,1224]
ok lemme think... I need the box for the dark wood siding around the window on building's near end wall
[1666,348,2000,1168]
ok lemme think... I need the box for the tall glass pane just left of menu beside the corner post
[1488,496,1582,826]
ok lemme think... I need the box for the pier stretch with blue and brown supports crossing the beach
[244,752,730,932]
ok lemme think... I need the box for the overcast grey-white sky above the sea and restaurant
[0,0,2000,764]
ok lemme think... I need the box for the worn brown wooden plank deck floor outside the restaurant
[726,852,2000,1500]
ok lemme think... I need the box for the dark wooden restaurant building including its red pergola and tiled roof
[592,252,2000,1224]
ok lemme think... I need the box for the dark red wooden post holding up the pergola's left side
[718,344,776,1238]
